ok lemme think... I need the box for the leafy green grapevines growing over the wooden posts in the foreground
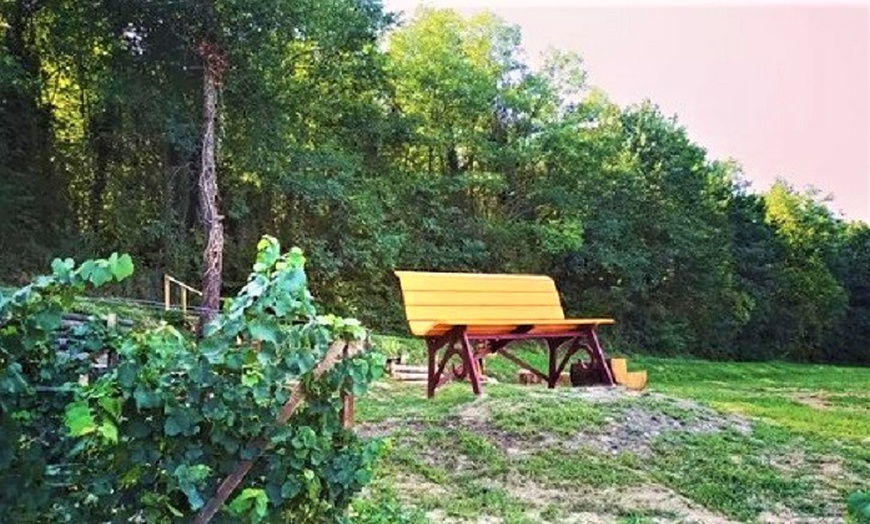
[0,236,384,522]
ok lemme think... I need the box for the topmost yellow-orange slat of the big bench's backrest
[395,271,556,293]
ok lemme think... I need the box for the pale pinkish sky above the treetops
[384,0,870,223]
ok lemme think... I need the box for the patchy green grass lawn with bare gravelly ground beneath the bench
[357,339,870,523]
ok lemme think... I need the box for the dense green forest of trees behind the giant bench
[0,0,870,364]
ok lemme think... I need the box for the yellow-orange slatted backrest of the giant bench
[395,271,565,335]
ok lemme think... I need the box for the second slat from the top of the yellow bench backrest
[403,290,562,308]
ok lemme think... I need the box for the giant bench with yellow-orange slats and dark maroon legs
[395,271,614,397]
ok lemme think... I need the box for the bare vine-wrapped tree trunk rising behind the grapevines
[198,43,224,325]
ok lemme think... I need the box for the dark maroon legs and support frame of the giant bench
[425,323,615,398]
